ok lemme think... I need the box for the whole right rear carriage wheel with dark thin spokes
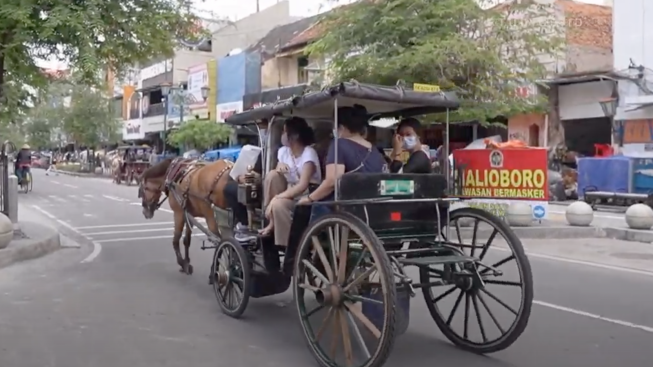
[420,208,533,354]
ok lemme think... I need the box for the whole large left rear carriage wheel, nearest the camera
[293,213,396,367]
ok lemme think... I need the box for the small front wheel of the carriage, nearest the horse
[211,239,252,318]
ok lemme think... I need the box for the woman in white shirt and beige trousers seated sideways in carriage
[261,117,322,246]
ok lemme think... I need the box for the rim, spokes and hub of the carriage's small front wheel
[213,244,245,311]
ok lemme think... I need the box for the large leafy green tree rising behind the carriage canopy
[307,0,562,122]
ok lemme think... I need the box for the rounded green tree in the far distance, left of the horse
[60,86,121,149]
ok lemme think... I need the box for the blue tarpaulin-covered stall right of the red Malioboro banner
[578,156,633,197]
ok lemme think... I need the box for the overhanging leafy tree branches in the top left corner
[0,0,205,120]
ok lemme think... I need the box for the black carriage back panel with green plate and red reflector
[339,173,448,239]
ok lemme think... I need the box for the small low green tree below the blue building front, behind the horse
[168,120,232,151]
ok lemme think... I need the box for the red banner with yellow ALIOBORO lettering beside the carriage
[453,149,549,201]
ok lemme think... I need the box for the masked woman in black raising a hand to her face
[390,118,432,173]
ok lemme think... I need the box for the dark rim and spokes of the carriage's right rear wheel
[425,213,527,346]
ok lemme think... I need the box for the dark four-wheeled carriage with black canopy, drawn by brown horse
[140,83,533,367]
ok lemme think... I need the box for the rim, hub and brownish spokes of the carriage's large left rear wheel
[293,218,394,366]
